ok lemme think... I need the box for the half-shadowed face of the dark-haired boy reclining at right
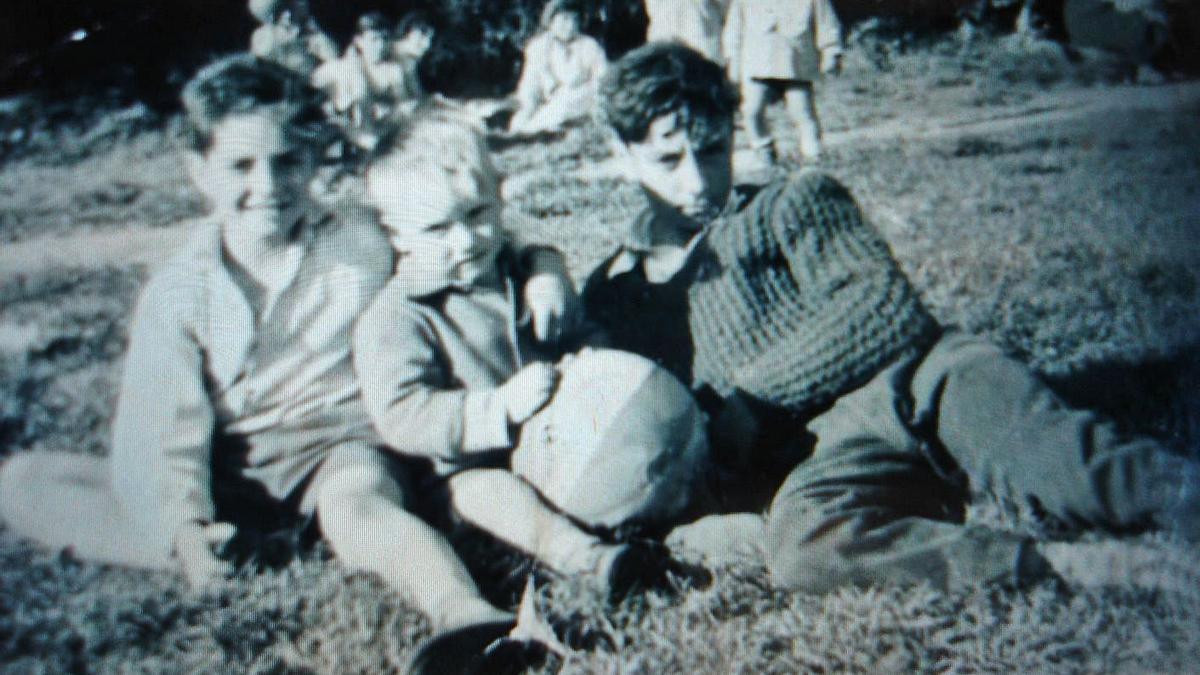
[618,113,733,231]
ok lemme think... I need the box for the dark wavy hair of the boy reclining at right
[600,42,738,143]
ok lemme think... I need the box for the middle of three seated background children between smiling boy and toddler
[312,12,410,149]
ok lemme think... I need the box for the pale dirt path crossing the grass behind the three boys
[0,82,1200,279]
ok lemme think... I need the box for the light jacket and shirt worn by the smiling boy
[110,216,391,542]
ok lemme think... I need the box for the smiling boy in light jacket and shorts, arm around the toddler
[0,56,583,672]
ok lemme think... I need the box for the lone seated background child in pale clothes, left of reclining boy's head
[509,0,607,135]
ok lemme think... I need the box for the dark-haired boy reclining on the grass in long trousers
[583,43,1200,591]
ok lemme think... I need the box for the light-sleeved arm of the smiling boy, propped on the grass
[112,279,215,554]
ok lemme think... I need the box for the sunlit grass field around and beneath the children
[0,34,1200,674]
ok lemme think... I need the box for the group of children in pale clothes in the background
[251,0,841,163]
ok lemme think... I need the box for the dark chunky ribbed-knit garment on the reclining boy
[689,172,940,411]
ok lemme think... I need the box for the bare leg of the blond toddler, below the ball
[450,468,620,574]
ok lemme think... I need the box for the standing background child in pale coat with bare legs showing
[721,0,841,162]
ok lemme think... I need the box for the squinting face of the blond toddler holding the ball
[367,159,503,286]
